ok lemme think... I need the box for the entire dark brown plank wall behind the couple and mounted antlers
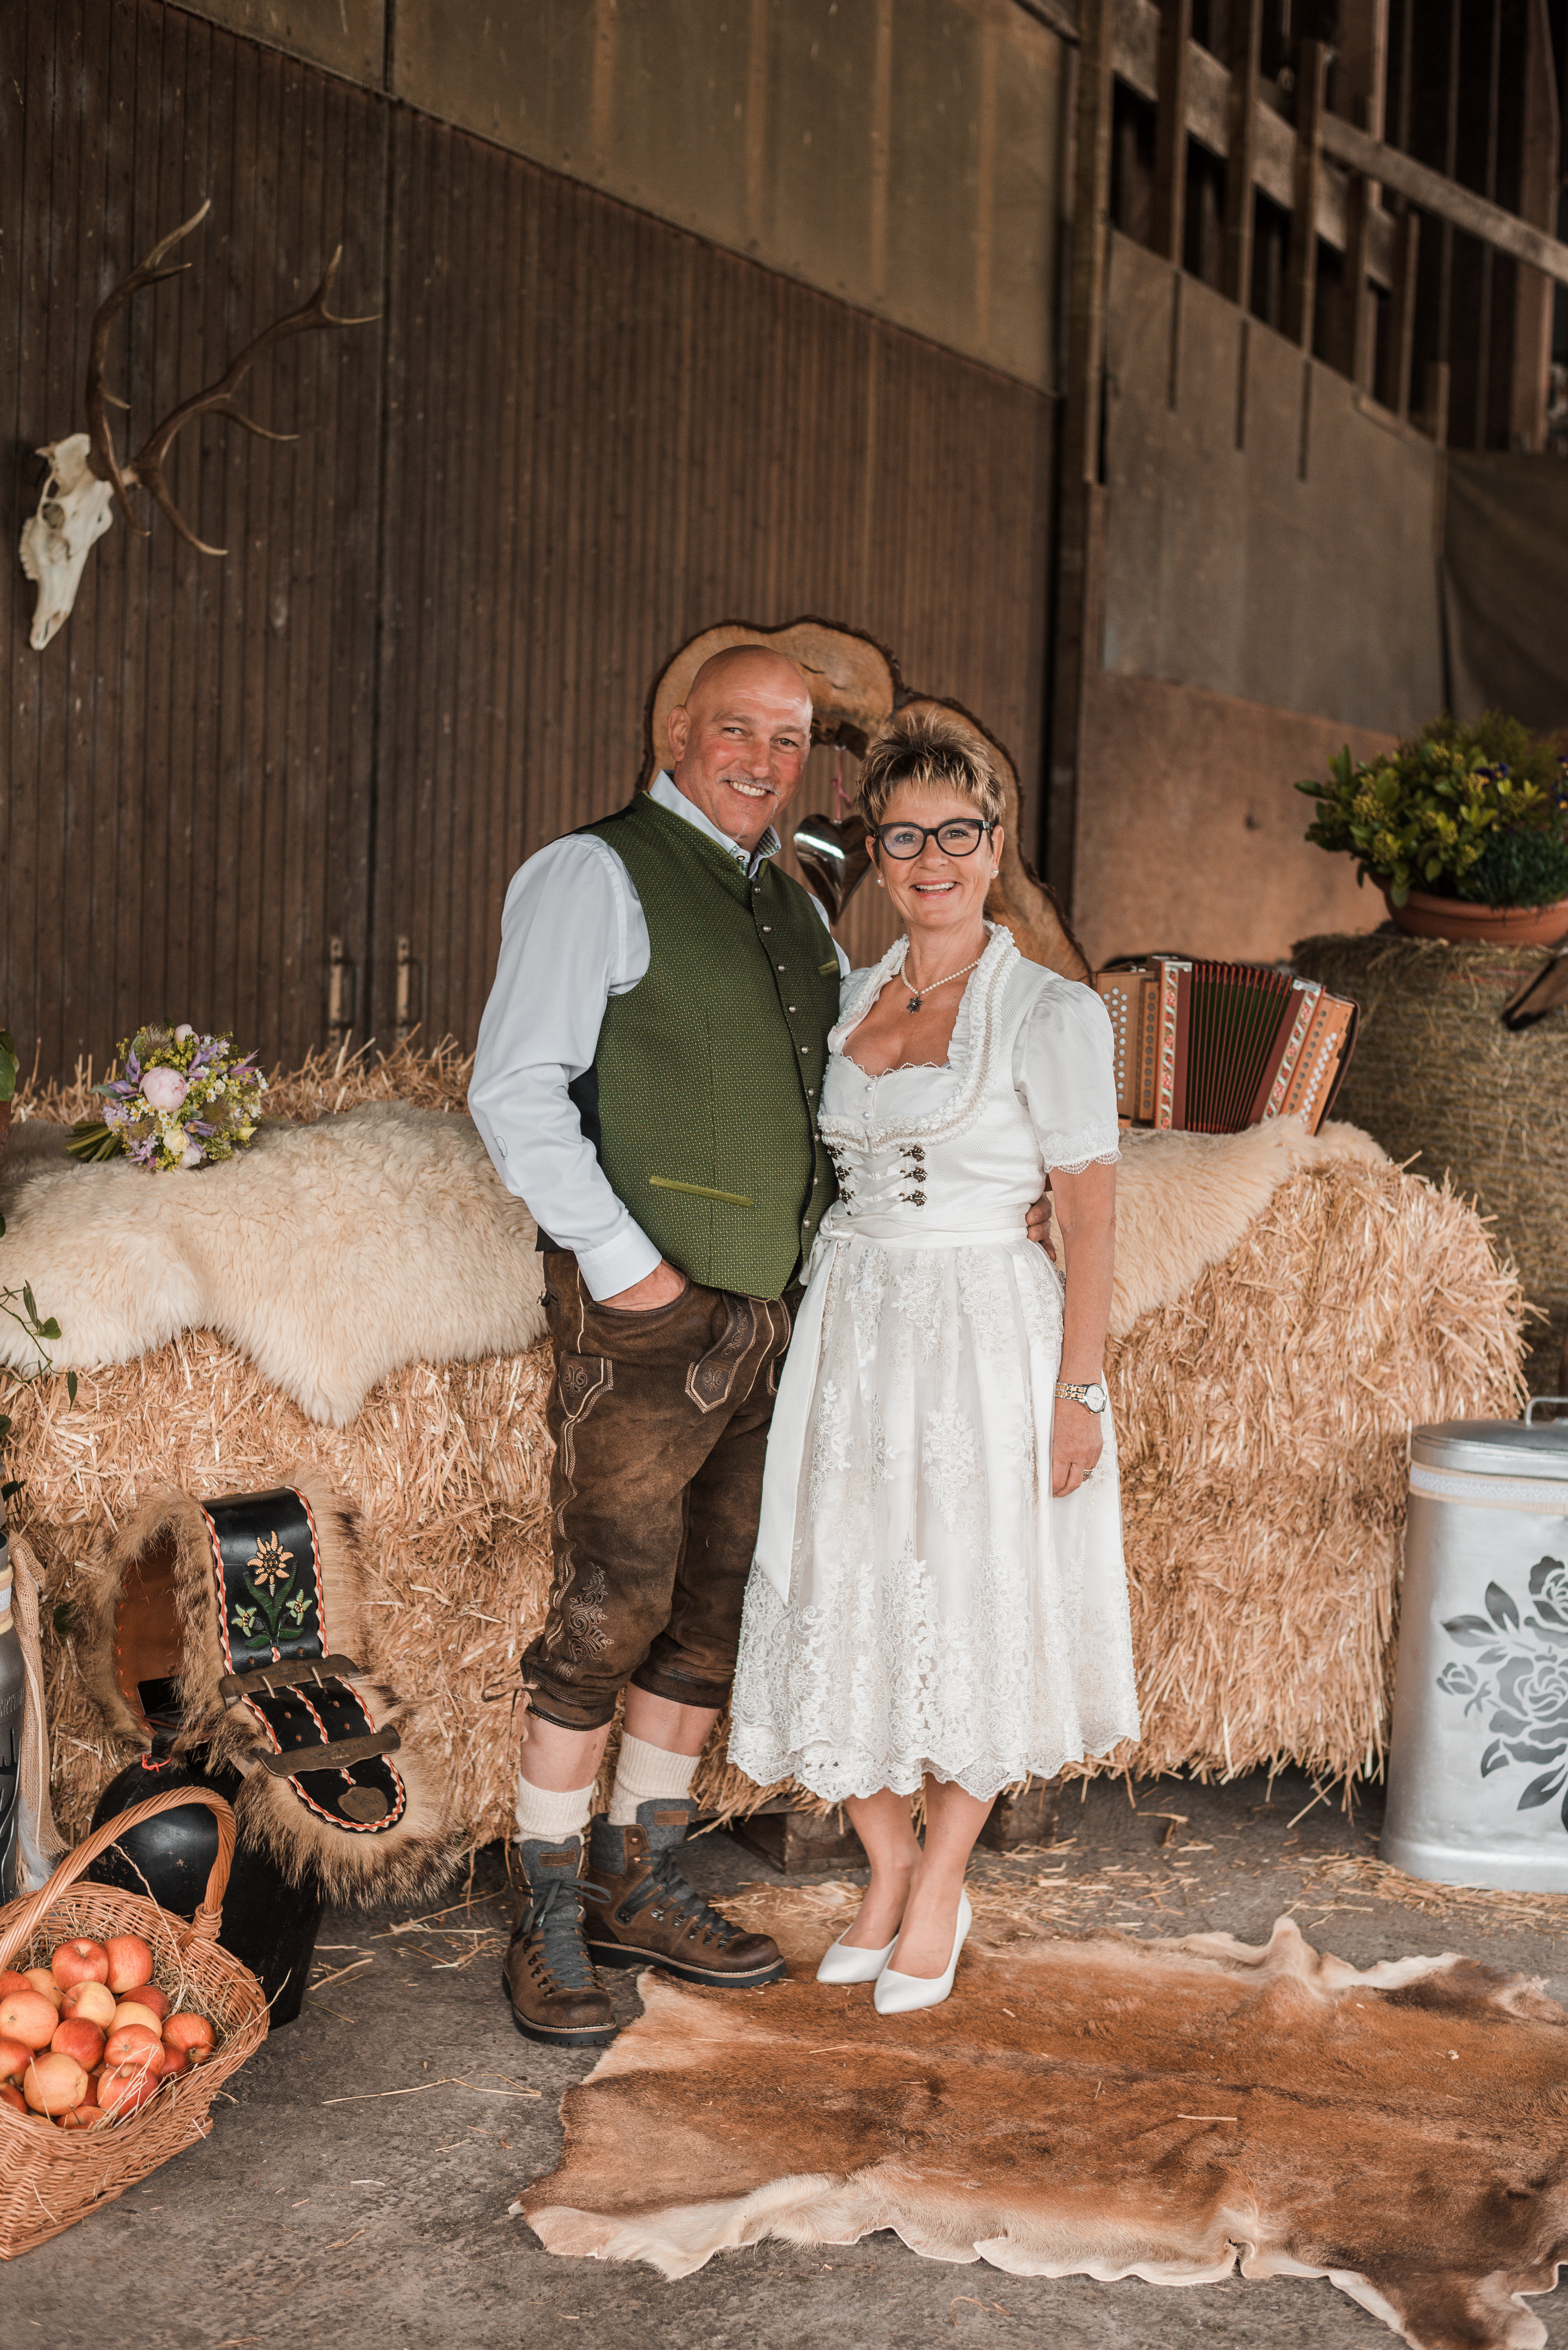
[0,0,1053,1072]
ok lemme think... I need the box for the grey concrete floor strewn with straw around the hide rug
[0,1774,1568,2350]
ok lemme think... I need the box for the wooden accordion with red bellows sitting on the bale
[1096,954,1359,1135]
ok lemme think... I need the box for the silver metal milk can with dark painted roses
[1380,1398,1568,1894]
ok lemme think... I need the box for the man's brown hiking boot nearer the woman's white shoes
[583,1795,788,1990]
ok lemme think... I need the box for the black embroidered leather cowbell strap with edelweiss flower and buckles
[202,1485,409,1835]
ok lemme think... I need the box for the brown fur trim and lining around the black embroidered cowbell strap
[78,1469,456,1901]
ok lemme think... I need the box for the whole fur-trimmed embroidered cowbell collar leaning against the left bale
[80,1471,456,1901]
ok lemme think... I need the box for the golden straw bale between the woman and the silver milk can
[1107,1158,1523,1777]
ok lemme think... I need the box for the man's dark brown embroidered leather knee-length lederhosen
[524,1253,788,1730]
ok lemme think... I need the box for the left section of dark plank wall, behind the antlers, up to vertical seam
[0,0,388,1074]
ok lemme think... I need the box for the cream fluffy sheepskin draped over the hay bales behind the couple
[0,1102,1382,1427]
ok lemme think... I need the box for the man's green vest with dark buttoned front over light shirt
[571,792,839,1297]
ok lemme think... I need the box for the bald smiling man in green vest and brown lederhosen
[468,646,849,2047]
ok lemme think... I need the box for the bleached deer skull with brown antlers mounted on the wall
[21,197,372,653]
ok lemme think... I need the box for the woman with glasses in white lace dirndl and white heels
[729,717,1138,2014]
